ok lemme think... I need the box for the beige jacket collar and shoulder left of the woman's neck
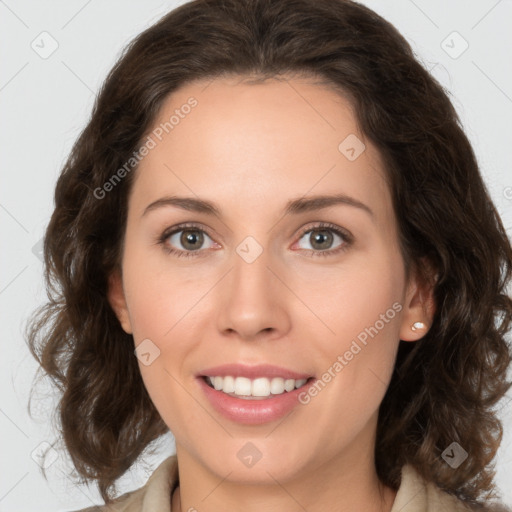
[66,455,178,512]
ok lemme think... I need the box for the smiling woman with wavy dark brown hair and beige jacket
[29,0,512,512]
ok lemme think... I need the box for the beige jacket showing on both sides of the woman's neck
[70,455,512,512]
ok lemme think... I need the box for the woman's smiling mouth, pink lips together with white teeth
[197,364,316,425]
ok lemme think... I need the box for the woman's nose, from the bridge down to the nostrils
[217,245,293,341]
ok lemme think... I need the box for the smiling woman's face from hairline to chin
[110,78,424,488]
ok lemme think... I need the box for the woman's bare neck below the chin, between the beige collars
[171,436,396,512]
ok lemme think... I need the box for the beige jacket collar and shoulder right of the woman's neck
[391,464,512,512]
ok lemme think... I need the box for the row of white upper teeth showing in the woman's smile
[206,376,307,397]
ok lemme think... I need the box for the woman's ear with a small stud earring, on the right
[400,259,437,341]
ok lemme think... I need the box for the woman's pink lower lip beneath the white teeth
[198,377,310,425]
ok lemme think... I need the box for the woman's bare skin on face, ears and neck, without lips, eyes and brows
[109,77,432,512]
